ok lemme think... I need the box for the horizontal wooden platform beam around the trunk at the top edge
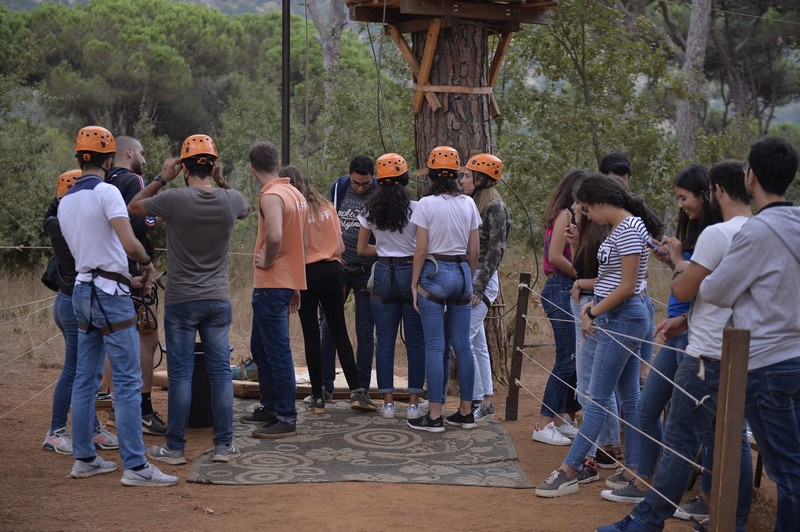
[400,0,550,24]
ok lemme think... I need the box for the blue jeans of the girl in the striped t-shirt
[564,295,648,470]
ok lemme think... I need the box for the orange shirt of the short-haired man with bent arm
[253,177,308,290]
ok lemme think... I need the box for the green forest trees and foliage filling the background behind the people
[0,0,800,269]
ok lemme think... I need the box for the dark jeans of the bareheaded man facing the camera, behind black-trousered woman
[319,268,375,391]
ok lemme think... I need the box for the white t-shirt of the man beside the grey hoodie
[686,216,748,359]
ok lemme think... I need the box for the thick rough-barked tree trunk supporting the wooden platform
[412,24,508,395]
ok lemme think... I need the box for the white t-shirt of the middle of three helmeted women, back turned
[411,194,481,255]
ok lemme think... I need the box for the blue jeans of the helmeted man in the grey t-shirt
[164,300,233,450]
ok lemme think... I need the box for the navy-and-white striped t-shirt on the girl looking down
[594,216,650,299]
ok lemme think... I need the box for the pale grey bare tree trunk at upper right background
[675,0,711,161]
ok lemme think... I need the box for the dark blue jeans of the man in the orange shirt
[250,288,297,423]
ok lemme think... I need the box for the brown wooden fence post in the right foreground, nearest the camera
[708,327,750,532]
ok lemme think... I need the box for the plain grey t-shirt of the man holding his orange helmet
[144,187,248,305]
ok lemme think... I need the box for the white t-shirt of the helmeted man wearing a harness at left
[58,176,130,295]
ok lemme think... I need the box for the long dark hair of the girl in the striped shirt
[575,173,664,238]
